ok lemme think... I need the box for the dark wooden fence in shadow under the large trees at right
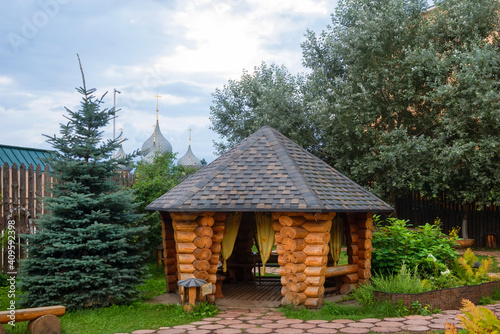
[396,194,500,247]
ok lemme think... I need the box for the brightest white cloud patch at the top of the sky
[155,0,328,78]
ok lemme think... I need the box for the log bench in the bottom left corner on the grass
[0,305,66,334]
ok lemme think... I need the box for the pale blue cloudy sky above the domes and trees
[0,0,337,163]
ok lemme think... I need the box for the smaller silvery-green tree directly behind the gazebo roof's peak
[210,63,315,153]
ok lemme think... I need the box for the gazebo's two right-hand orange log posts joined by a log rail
[273,212,373,308]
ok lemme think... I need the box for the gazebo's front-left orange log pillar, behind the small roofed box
[170,212,226,302]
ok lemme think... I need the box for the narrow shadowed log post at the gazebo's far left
[160,212,177,292]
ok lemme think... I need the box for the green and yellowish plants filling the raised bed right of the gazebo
[352,217,500,314]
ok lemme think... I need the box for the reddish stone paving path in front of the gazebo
[116,304,500,334]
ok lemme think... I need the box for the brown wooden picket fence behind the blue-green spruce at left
[0,163,135,273]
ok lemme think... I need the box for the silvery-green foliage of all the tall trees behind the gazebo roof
[211,0,500,209]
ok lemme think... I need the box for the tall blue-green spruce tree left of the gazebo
[20,59,147,309]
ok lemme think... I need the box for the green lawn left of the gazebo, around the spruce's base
[0,264,217,334]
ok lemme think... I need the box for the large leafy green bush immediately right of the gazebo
[372,216,458,277]
